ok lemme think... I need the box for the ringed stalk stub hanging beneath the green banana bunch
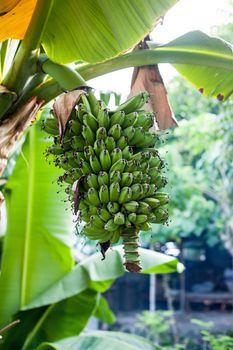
[121,229,141,272]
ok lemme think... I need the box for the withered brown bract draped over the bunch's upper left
[53,90,86,140]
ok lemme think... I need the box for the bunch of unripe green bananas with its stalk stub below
[42,91,169,272]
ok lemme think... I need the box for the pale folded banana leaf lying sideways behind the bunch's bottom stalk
[22,246,183,310]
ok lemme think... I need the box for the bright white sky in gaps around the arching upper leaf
[88,0,228,97]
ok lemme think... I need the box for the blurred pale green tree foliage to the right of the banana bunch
[142,77,233,253]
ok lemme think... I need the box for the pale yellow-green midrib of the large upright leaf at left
[20,128,36,307]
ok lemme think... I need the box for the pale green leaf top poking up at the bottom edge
[36,331,159,350]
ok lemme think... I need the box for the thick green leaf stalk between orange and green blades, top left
[2,0,54,94]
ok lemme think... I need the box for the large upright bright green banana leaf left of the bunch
[0,121,73,324]
